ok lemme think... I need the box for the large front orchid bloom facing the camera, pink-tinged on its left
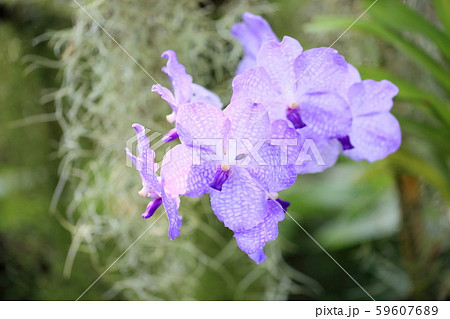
[161,99,296,262]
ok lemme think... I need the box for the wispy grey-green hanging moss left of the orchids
[47,0,315,300]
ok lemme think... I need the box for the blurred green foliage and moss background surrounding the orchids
[0,0,450,300]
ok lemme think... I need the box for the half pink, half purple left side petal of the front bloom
[161,144,218,197]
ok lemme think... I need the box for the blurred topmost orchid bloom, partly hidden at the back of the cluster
[231,12,278,74]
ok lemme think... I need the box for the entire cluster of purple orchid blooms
[127,13,401,263]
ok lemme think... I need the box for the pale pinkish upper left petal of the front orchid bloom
[176,102,230,146]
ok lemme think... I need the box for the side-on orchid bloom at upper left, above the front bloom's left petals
[152,50,223,142]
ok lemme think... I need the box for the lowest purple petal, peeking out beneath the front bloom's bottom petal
[234,200,285,255]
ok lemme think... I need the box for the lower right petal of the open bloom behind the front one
[299,93,352,138]
